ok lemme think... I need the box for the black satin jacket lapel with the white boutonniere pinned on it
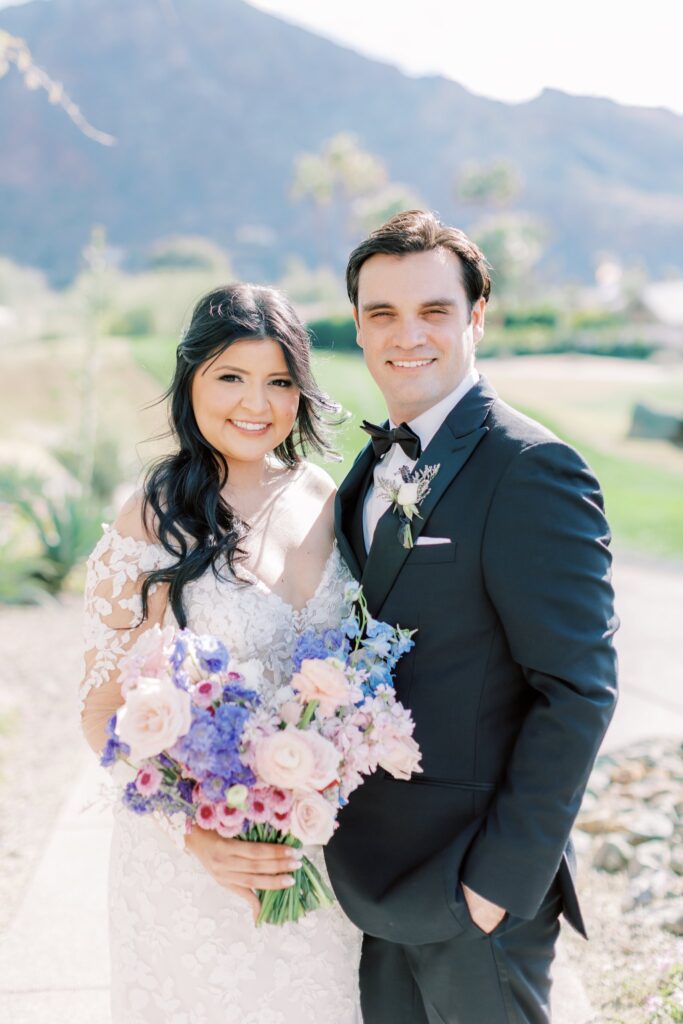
[361,378,496,614]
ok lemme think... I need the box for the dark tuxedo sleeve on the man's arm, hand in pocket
[461,441,617,919]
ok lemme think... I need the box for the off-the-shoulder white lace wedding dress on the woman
[81,527,360,1024]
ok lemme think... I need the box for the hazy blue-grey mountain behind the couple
[0,0,683,283]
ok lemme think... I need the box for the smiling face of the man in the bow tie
[353,249,485,423]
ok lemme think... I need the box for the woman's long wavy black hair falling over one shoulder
[141,284,339,628]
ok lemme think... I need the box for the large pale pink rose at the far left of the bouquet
[116,676,191,761]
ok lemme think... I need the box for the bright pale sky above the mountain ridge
[5,0,683,114]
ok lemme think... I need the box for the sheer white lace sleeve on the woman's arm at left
[79,525,173,751]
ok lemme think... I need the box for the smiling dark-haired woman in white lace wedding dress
[81,285,360,1024]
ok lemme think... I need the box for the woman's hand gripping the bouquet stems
[185,827,302,920]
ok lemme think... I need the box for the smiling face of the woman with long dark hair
[191,338,300,462]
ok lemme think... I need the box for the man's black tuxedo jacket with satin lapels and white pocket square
[326,378,617,945]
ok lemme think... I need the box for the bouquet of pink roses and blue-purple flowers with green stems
[100,583,422,924]
